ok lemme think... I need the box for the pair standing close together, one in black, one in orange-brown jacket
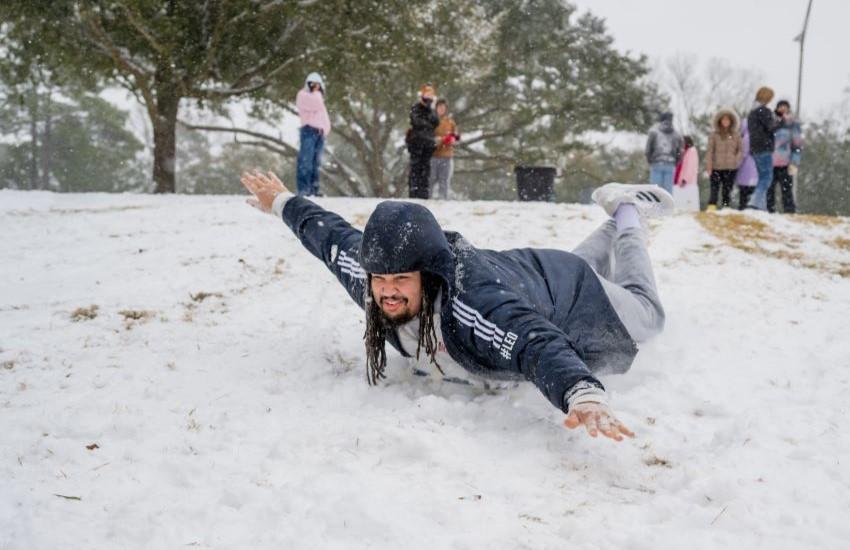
[404,84,460,199]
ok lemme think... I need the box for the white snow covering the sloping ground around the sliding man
[0,191,850,550]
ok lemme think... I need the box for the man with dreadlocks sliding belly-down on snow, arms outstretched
[242,172,673,441]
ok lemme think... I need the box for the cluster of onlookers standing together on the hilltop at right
[646,87,803,214]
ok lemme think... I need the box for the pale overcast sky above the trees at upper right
[570,0,850,118]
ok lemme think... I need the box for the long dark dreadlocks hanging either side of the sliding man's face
[363,271,443,386]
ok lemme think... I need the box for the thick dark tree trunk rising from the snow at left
[151,82,180,193]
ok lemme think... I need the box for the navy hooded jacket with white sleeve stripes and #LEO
[283,197,637,412]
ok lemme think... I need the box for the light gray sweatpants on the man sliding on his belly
[573,219,664,342]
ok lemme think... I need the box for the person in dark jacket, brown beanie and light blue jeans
[747,86,777,210]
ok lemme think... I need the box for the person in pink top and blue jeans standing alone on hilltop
[295,73,331,195]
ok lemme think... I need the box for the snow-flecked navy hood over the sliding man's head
[360,201,454,284]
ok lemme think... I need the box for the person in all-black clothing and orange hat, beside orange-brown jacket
[406,84,440,199]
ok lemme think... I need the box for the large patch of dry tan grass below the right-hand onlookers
[696,212,850,277]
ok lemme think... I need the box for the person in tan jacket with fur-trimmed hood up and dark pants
[705,109,744,211]
